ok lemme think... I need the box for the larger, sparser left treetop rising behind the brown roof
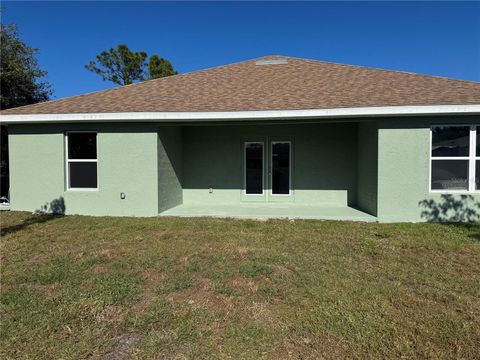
[85,44,147,85]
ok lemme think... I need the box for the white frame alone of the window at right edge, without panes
[428,124,480,194]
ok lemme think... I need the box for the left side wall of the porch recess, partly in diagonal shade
[158,126,183,213]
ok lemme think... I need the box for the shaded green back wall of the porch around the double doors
[183,123,357,206]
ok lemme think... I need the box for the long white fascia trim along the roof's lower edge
[0,104,480,124]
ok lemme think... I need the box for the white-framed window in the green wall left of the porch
[65,131,98,190]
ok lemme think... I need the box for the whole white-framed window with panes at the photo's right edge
[430,125,480,192]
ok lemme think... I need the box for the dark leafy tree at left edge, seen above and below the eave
[0,24,52,196]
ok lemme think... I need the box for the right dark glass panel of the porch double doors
[272,142,290,195]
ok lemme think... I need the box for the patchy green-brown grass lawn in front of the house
[0,212,480,360]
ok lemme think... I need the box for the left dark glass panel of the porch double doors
[245,143,263,195]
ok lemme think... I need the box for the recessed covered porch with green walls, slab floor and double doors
[158,119,378,221]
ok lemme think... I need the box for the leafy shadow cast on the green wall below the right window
[418,194,480,240]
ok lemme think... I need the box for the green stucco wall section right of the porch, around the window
[378,116,480,222]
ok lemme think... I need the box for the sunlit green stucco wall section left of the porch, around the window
[9,124,158,216]
